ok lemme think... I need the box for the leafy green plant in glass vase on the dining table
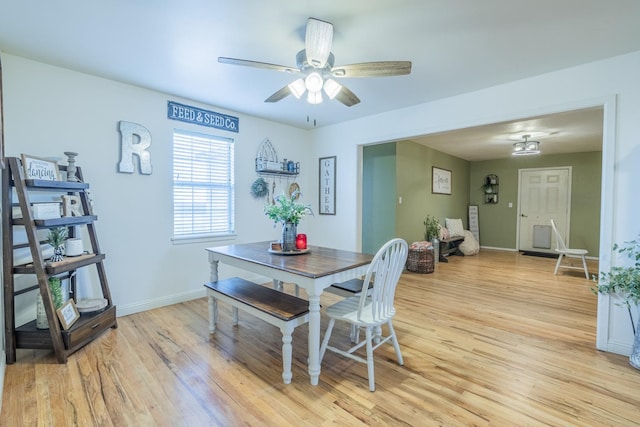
[264,190,313,252]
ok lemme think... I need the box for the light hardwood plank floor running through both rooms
[0,251,640,426]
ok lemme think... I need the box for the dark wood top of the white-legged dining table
[207,242,373,279]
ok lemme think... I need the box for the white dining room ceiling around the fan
[0,0,640,158]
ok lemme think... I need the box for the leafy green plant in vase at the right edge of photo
[593,238,640,369]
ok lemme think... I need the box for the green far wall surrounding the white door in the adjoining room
[469,151,602,257]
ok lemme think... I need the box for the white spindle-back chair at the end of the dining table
[320,239,408,391]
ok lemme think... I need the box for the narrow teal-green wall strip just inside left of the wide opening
[362,142,396,254]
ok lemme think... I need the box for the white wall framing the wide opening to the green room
[304,52,640,354]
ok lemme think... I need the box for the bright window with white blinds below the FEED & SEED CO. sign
[173,130,235,239]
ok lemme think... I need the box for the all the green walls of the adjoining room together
[362,141,602,257]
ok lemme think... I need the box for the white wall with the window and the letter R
[2,55,317,315]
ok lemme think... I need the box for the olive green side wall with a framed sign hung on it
[396,141,470,244]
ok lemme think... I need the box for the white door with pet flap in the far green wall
[518,166,571,252]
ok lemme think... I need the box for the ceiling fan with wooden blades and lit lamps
[218,18,411,107]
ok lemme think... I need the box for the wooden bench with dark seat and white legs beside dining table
[204,277,309,384]
